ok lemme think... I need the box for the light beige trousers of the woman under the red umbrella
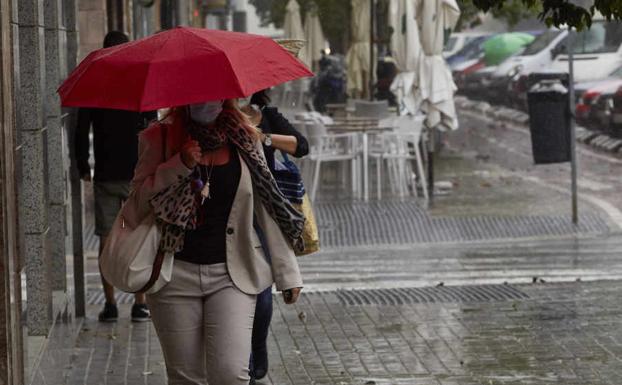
[147,261,256,385]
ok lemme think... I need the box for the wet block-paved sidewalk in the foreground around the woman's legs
[59,281,622,385]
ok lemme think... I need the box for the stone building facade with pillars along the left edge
[0,0,84,384]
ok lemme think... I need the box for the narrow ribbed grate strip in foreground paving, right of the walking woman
[336,285,529,306]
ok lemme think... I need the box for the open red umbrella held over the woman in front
[58,27,313,111]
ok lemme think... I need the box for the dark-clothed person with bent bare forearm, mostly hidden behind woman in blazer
[250,90,309,383]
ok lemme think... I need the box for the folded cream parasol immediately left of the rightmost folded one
[389,0,422,115]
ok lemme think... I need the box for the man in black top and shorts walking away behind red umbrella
[75,31,157,322]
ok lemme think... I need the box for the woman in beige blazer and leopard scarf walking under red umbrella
[124,100,304,385]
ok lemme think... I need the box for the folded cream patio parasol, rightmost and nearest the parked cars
[415,0,460,130]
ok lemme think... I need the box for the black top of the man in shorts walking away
[75,108,157,182]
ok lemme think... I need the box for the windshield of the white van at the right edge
[574,21,622,54]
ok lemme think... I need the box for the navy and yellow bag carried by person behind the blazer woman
[274,151,320,256]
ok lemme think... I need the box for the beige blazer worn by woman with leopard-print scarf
[123,123,302,294]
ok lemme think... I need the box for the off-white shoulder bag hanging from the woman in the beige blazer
[99,125,174,294]
